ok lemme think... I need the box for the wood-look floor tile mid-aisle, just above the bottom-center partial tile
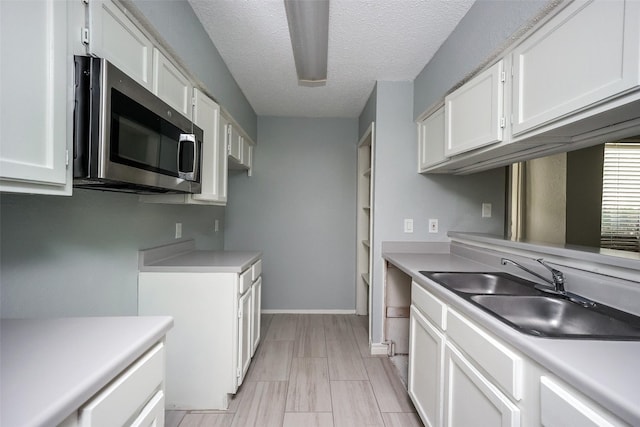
[286,358,331,412]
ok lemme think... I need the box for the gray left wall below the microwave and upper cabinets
[0,190,224,318]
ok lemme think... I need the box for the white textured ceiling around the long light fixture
[189,0,474,117]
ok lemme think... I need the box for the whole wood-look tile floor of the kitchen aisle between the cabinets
[165,314,422,427]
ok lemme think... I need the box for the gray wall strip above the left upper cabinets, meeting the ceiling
[129,0,257,141]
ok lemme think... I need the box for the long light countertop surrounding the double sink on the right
[383,253,640,426]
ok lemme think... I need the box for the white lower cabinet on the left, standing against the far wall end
[138,261,260,410]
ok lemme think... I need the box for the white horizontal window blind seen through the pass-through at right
[600,142,640,252]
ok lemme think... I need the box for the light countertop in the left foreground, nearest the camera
[0,317,173,427]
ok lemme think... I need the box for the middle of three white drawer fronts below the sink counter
[447,309,523,400]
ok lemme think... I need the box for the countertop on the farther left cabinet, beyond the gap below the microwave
[138,240,262,273]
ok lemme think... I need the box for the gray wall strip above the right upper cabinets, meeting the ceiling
[413,0,548,118]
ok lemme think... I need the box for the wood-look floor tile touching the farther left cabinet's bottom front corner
[231,381,287,427]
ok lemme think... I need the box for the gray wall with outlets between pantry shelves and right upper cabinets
[372,82,504,342]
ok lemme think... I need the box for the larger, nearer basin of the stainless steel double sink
[470,295,640,340]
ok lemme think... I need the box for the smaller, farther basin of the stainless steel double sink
[420,271,540,295]
